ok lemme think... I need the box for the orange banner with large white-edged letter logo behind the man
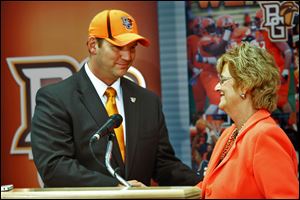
[1,1,161,187]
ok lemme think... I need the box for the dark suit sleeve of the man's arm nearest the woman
[155,96,200,186]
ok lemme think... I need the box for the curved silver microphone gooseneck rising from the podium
[105,133,132,187]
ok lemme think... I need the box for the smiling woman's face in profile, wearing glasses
[215,63,241,114]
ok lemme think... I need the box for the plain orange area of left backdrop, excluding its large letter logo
[1,1,161,187]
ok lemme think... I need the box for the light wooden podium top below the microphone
[1,186,201,199]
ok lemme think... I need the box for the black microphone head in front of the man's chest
[90,114,123,142]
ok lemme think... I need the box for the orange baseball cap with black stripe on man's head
[89,10,150,46]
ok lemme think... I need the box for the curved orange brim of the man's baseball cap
[105,33,150,47]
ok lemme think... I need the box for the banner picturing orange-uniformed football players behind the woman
[186,1,299,174]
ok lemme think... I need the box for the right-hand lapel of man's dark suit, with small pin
[121,78,141,178]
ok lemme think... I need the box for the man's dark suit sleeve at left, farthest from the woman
[31,87,118,187]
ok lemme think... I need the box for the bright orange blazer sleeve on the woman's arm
[253,127,299,198]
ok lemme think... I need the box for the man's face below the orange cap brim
[95,40,137,80]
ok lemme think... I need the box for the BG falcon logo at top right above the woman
[260,1,299,42]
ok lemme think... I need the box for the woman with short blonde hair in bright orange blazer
[197,43,299,198]
